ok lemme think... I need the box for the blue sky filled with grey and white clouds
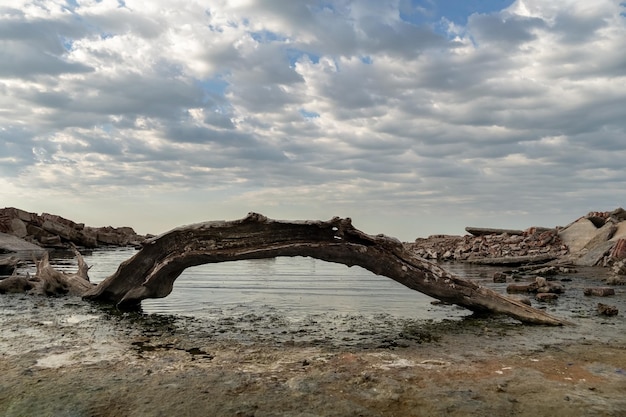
[0,0,626,240]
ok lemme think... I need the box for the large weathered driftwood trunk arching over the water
[85,213,567,325]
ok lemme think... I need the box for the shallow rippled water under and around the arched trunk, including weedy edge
[8,245,626,343]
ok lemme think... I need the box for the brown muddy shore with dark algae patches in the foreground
[0,270,626,417]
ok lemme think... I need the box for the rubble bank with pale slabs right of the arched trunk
[406,208,626,268]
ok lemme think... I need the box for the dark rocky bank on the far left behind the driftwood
[0,207,145,248]
